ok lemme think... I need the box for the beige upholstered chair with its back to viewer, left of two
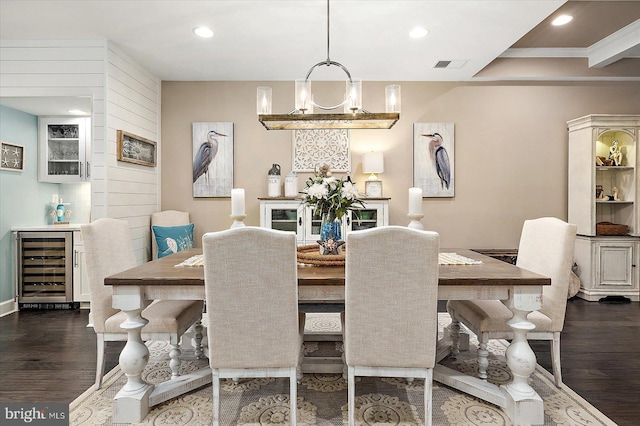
[202,227,305,426]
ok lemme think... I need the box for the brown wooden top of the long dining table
[104,249,551,286]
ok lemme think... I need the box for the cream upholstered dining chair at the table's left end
[80,218,204,389]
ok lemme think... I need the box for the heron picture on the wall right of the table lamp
[413,123,455,198]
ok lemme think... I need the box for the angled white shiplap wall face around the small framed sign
[105,43,161,263]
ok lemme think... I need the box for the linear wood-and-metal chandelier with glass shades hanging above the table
[256,0,400,130]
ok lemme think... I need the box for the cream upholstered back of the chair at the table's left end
[80,218,136,333]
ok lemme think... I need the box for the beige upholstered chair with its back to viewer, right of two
[344,226,439,426]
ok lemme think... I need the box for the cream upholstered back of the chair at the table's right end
[516,217,576,332]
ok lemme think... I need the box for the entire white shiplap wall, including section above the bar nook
[0,39,161,263]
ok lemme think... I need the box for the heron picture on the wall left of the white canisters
[193,122,238,197]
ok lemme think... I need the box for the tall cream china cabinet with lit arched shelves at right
[567,114,640,301]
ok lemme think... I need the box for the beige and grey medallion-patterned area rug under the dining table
[70,313,615,426]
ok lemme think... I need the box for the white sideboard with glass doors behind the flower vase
[260,197,389,245]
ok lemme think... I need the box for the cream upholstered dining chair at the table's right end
[447,217,576,387]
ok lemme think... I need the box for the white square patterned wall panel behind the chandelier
[292,129,351,172]
